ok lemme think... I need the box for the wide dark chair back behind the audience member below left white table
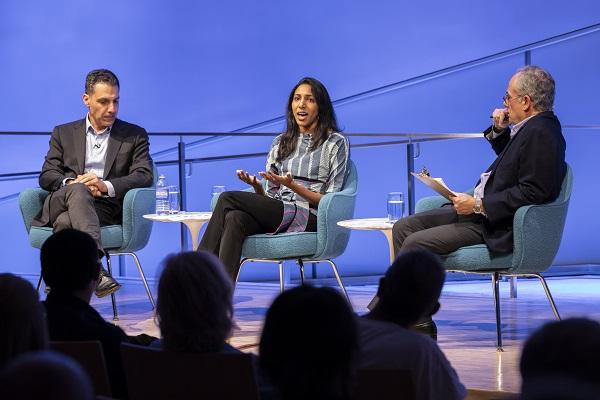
[121,343,258,400]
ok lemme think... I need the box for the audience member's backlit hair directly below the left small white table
[156,251,233,352]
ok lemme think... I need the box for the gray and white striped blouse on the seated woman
[266,132,350,233]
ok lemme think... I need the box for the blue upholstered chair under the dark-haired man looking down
[19,180,156,321]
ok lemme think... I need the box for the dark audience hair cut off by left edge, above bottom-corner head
[0,274,48,369]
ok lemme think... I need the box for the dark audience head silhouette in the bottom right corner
[520,318,600,400]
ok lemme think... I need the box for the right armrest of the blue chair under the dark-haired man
[119,188,156,252]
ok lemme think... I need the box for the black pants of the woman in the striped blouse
[198,191,317,281]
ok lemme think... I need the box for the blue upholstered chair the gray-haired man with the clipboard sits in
[416,165,573,351]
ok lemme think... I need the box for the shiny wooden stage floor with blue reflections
[77,276,600,392]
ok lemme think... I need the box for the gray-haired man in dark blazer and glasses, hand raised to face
[392,66,567,338]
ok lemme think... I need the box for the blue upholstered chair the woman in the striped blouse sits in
[212,160,358,298]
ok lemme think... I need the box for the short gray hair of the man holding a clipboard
[516,65,555,112]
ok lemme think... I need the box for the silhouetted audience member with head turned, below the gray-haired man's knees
[358,250,467,400]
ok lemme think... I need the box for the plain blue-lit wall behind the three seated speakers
[0,0,600,278]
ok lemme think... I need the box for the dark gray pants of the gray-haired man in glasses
[392,205,484,257]
